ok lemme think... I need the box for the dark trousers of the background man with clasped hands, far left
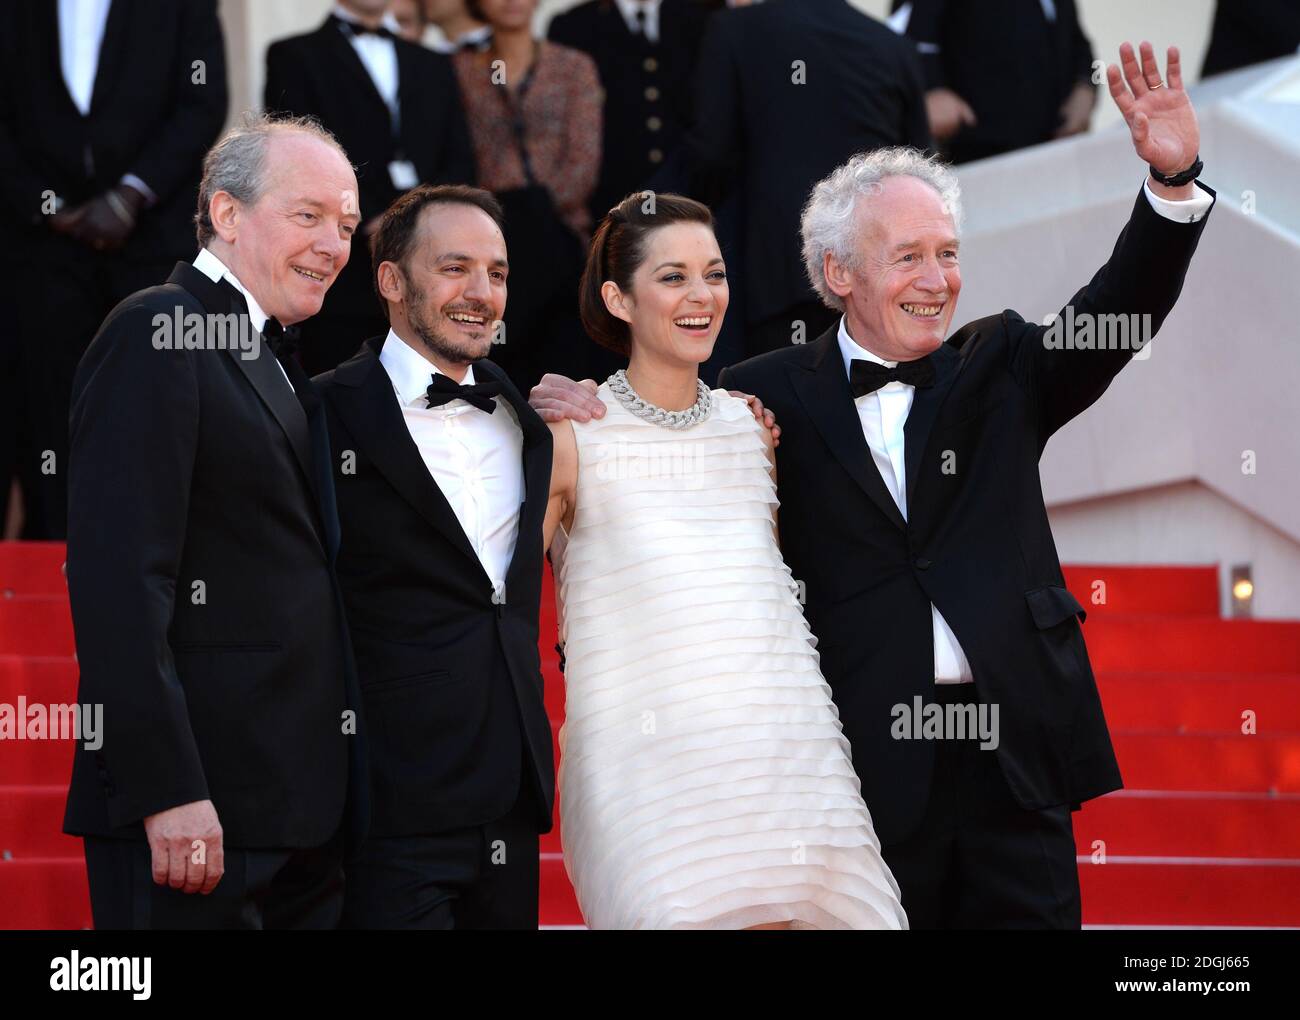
[13,240,176,539]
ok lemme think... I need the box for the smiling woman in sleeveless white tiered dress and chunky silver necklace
[543,195,907,929]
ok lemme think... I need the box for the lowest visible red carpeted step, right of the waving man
[1079,856,1300,928]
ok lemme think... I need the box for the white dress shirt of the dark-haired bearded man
[380,330,524,600]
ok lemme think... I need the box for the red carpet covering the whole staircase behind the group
[0,543,1300,928]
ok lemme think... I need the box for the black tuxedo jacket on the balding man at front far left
[65,264,364,847]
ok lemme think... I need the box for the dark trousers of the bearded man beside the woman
[345,767,540,930]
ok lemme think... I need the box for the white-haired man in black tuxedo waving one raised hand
[533,43,1213,928]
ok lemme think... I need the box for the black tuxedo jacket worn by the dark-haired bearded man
[316,338,555,837]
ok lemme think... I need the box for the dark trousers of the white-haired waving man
[881,683,1080,929]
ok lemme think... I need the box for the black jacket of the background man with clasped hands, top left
[0,0,226,261]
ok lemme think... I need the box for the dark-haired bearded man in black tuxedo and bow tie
[316,186,555,929]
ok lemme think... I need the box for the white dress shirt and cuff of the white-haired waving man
[839,185,1214,683]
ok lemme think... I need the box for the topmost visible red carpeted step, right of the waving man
[1062,564,1219,618]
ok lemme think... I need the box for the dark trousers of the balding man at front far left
[86,830,343,930]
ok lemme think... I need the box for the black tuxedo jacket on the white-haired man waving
[719,183,1206,845]
